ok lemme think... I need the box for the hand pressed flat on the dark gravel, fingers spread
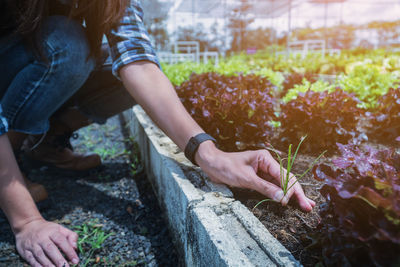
[15,219,79,267]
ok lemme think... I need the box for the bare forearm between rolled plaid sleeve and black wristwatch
[121,62,212,153]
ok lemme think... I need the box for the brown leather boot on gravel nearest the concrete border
[23,135,101,171]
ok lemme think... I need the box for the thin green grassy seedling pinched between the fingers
[253,136,326,210]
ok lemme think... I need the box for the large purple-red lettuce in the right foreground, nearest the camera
[313,144,400,266]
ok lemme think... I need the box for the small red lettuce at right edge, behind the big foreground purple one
[369,88,400,144]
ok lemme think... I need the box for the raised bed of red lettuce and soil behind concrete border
[173,73,400,266]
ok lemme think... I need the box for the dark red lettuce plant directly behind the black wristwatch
[176,73,275,151]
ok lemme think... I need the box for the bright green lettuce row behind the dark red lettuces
[163,50,400,86]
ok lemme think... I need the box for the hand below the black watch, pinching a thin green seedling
[195,141,315,212]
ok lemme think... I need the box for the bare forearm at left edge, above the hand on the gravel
[0,135,42,232]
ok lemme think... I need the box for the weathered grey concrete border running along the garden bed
[123,106,301,267]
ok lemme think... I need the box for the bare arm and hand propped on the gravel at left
[0,134,79,266]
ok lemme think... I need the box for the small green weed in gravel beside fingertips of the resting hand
[75,221,115,267]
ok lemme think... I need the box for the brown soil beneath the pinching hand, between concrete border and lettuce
[233,155,325,266]
